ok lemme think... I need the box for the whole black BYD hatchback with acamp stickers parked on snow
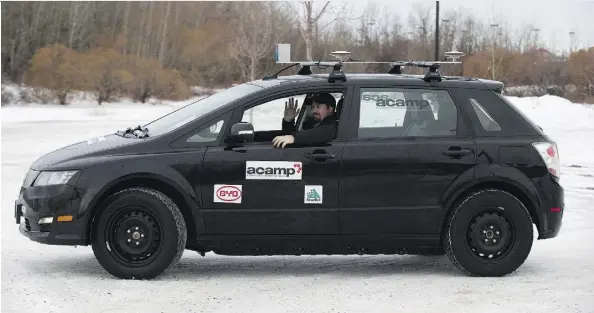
[15,55,564,279]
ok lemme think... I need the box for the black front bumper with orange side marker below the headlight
[14,185,86,245]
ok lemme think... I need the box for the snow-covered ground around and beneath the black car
[1,92,594,313]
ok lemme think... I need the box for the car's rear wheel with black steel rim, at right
[443,189,534,277]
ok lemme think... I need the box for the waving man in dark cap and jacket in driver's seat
[272,93,338,148]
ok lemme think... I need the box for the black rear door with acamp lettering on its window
[339,86,476,234]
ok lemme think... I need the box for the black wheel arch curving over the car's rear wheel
[439,177,541,233]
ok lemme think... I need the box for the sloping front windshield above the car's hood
[144,83,262,137]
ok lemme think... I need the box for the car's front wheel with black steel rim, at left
[92,188,187,279]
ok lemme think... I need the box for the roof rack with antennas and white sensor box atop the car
[262,44,464,83]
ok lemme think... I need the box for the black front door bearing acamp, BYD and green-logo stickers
[202,88,344,235]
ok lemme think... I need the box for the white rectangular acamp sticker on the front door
[245,161,303,180]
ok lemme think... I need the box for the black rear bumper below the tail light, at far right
[538,177,565,239]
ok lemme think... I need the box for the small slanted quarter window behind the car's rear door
[455,89,538,136]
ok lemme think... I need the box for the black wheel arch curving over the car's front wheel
[86,173,198,244]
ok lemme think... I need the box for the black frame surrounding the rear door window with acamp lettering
[347,84,471,142]
